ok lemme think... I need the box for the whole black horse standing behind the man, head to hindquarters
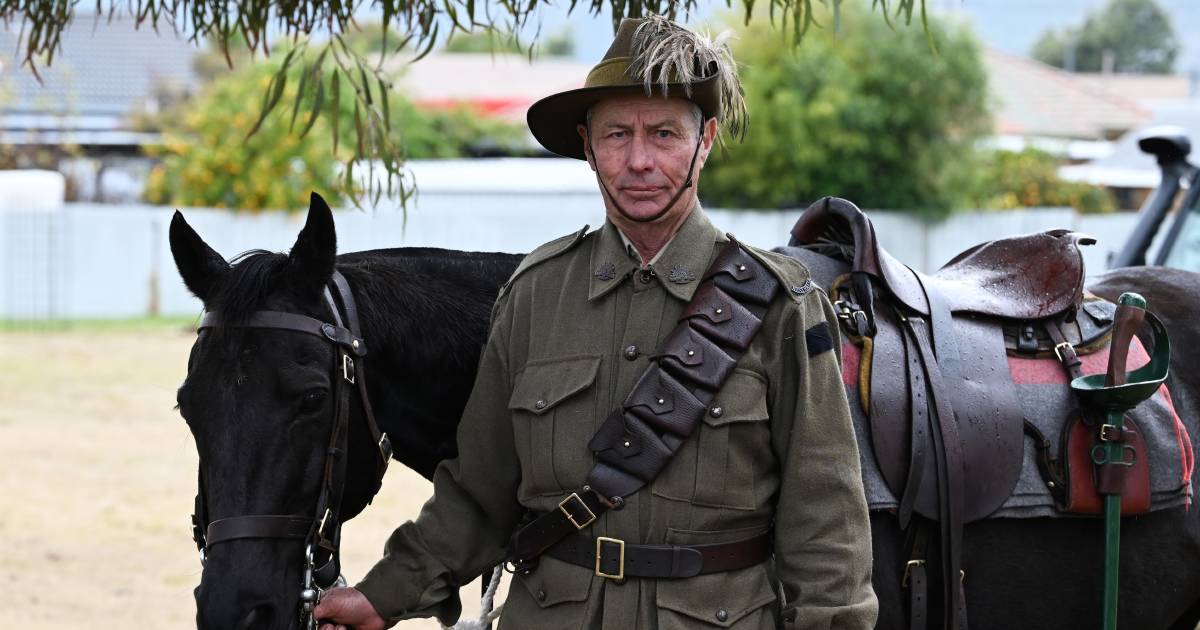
[170,197,1200,630]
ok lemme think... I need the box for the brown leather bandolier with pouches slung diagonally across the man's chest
[508,239,779,569]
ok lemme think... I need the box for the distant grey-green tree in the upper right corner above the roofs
[1033,0,1180,74]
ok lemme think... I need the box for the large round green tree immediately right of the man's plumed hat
[701,8,990,216]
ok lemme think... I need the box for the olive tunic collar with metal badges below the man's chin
[588,205,724,301]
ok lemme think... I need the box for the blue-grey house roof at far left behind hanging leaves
[0,16,197,123]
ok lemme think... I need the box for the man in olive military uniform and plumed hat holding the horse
[316,17,877,630]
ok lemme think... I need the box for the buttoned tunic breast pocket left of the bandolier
[509,355,600,500]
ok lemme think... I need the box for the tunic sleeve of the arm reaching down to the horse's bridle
[355,298,522,625]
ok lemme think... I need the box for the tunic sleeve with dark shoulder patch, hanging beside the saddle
[772,290,878,630]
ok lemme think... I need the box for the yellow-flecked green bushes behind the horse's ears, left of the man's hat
[145,45,524,211]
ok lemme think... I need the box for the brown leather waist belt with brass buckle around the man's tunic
[546,530,772,580]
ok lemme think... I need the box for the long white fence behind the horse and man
[0,199,1136,320]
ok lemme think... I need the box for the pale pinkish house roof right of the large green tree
[984,48,1151,140]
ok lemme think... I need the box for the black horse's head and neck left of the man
[170,196,521,630]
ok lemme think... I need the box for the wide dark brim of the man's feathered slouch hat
[526,74,721,160]
